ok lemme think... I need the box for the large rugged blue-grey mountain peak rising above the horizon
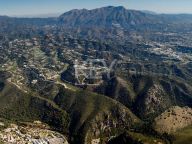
[59,6,162,28]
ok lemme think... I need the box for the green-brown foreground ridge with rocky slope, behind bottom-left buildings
[0,71,142,143]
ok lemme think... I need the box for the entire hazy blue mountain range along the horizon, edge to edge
[0,6,192,35]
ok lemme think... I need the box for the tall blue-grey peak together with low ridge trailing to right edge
[59,6,192,28]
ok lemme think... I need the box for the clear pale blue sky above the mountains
[0,0,192,16]
